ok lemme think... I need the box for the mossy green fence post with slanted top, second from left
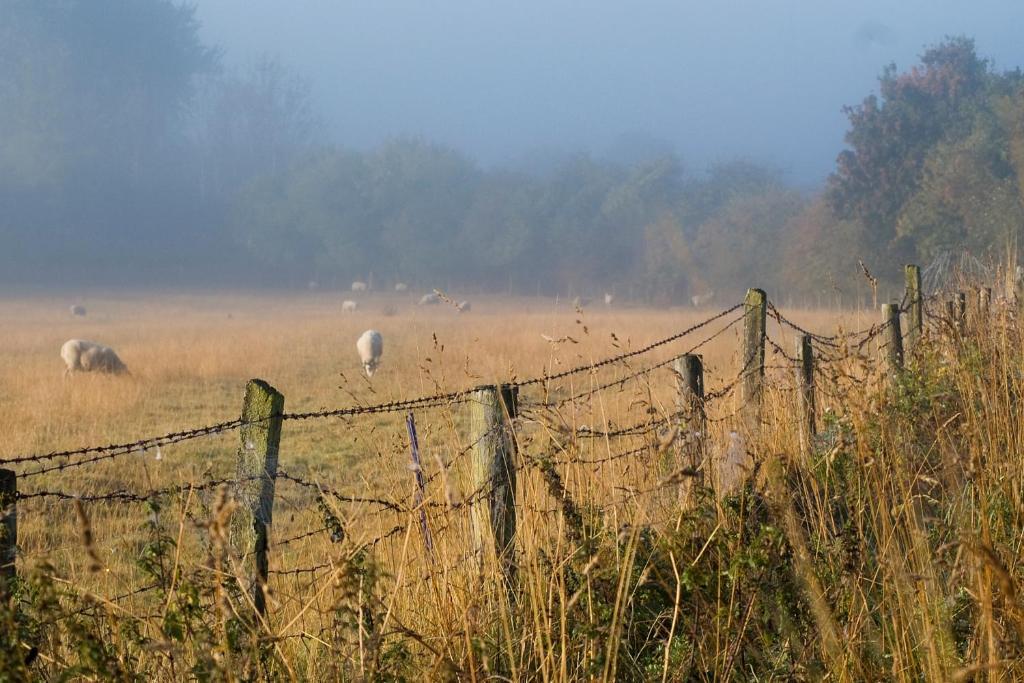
[230,380,285,614]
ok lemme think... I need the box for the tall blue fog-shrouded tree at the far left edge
[0,0,217,276]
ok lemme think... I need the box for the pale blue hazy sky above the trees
[197,0,1024,185]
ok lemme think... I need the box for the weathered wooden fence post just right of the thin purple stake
[470,384,519,581]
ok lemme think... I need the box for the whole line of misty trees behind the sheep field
[6,0,1024,302]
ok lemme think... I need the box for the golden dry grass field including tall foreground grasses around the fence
[0,286,1024,680]
